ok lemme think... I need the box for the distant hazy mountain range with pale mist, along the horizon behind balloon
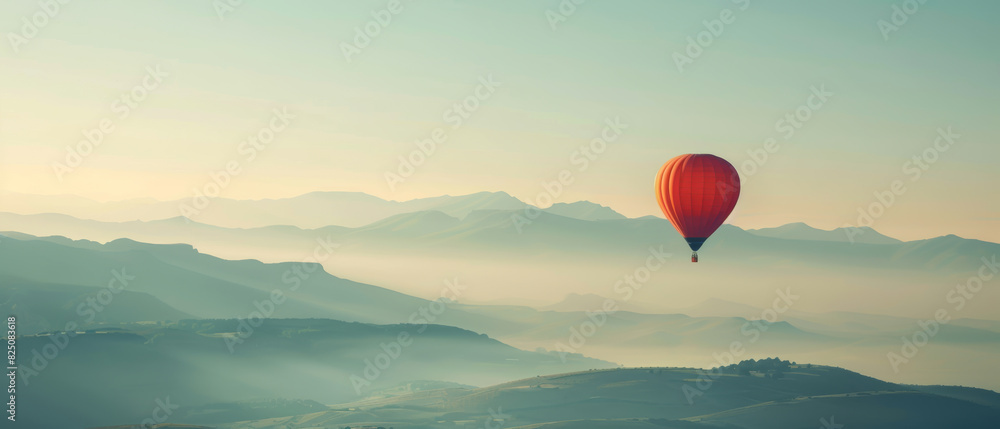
[0,201,1000,318]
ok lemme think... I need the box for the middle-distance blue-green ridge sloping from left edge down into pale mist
[0,234,1000,394]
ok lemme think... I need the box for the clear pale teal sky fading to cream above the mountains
[0,0,1000,242]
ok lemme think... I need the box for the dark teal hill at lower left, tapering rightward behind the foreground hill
[18,319,614,428]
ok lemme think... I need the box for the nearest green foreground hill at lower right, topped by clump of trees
[209,365,1000,429]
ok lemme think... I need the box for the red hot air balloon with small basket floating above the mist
[656,154,740,262]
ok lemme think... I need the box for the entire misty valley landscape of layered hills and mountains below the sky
[0,193,1000,428]
